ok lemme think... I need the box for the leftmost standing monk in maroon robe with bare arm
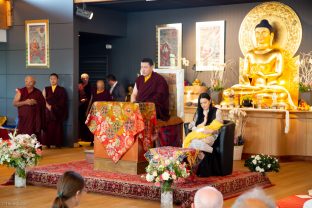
[13,76,45,142]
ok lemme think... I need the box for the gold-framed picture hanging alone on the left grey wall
[25,20,50,68]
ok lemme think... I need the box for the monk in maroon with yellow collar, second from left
[42,73,68,148]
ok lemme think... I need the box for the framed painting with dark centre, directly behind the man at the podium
[156,23,182,69]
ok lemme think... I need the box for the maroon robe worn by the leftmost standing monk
[17,87,45,142]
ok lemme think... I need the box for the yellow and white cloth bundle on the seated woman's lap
[183,119,223,152]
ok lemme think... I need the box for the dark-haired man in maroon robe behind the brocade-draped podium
[131,58,170,121]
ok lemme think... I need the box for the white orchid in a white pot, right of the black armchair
[228,108,247,160]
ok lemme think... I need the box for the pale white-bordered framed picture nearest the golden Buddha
[196,20,225,71]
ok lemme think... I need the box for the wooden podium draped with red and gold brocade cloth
[86,102,156,174]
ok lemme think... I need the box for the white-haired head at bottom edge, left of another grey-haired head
[192,186,223,208]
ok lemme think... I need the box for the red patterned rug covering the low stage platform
[21,161,272,207]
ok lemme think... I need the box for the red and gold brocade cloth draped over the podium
[86,102,156,163]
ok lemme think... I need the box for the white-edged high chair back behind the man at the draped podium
[154,69,184,118]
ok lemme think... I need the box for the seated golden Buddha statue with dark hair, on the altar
[221,19,296,109]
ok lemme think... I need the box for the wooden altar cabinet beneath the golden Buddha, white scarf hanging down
[221,108,312,160]
